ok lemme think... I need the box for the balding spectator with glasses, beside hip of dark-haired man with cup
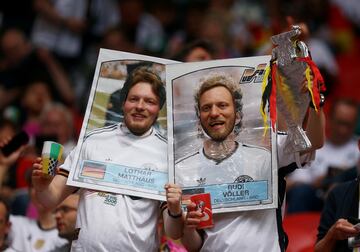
[55,194,79,252]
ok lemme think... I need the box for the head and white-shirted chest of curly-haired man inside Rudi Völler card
[175,74,271,186]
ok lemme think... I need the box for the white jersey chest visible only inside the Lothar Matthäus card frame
[80,124,167,172]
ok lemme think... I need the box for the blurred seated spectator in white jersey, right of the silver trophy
[287,99,360,213]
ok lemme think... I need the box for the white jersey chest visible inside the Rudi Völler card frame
[175,143,271,186]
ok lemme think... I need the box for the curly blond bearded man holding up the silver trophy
[167,73,324,251]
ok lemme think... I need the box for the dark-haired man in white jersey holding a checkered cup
[32,67,171,251]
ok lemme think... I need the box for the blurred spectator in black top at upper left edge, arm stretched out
[0,29,74,109]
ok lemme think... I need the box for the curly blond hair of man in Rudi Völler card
[194,72,243,134]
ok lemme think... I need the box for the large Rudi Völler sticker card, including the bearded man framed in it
[166,56,278,213]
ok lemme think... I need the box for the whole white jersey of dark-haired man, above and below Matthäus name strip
[61,124,167,251]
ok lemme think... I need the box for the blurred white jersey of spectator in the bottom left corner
[9,215,68,252]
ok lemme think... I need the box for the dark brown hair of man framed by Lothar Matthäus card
[120,66,166,109]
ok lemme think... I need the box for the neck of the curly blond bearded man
[204,133,237,160]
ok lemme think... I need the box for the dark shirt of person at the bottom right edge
[317,179,359,252]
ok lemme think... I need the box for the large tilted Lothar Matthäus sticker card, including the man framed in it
[67,49,177,200]
